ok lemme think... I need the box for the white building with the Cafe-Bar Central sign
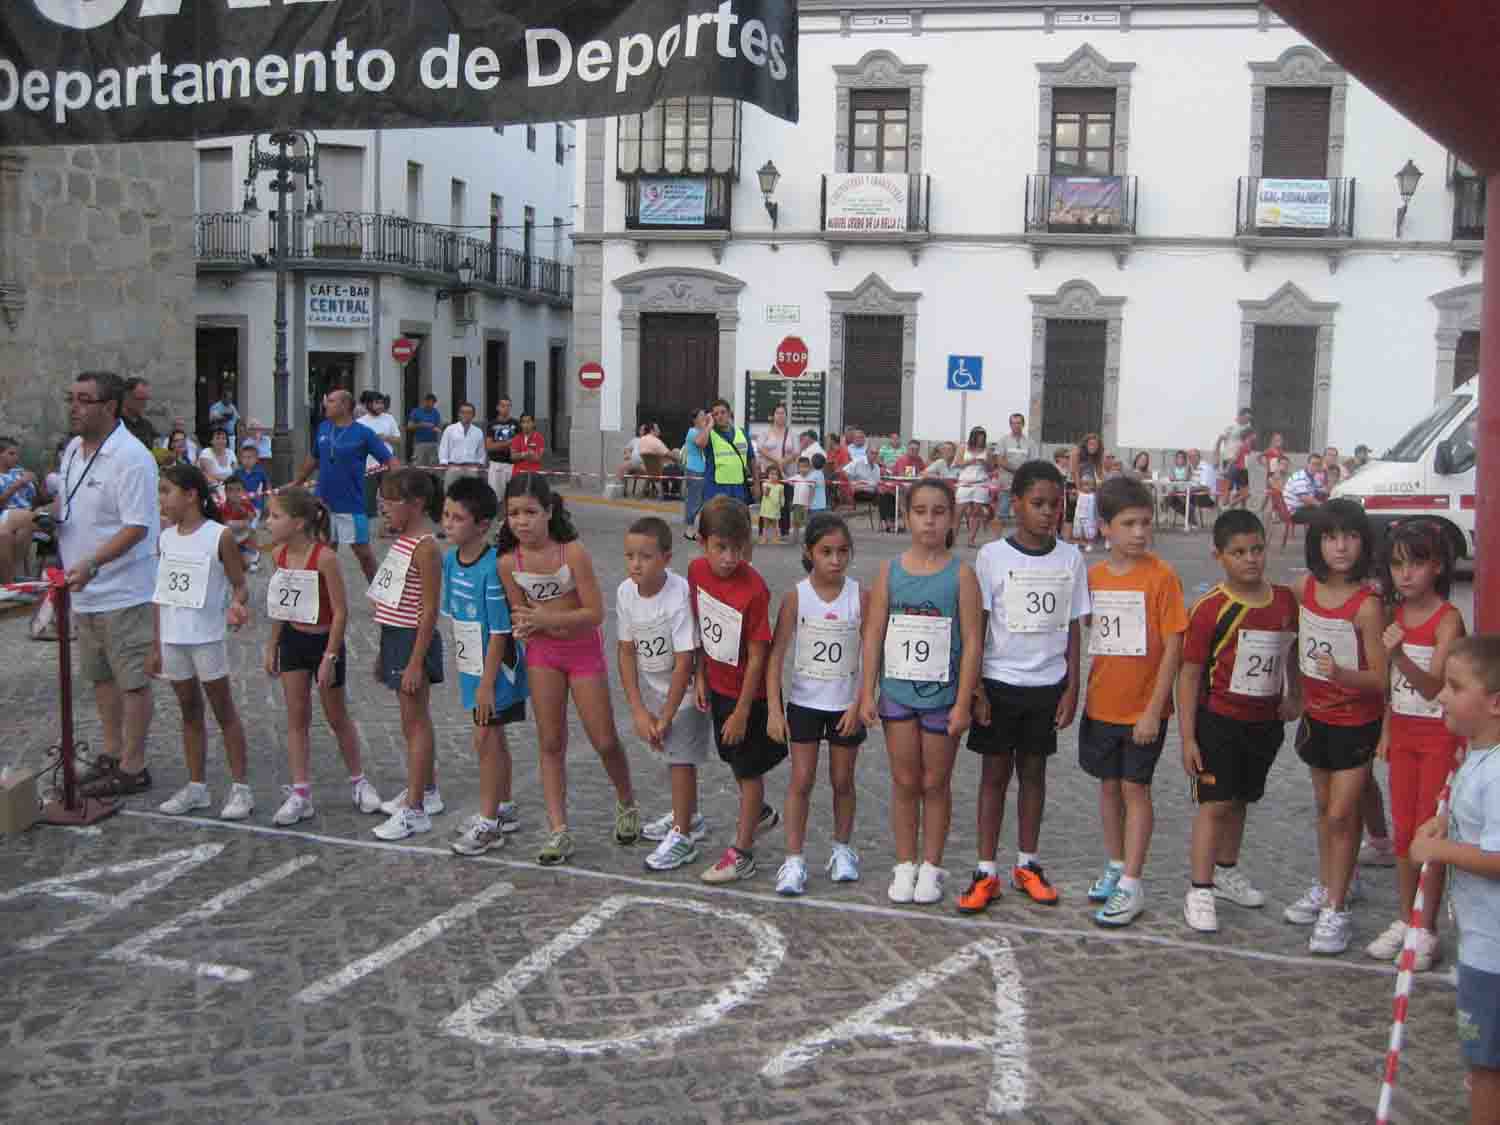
[189,125,576,468]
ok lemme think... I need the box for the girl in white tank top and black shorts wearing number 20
[767,513,870,894]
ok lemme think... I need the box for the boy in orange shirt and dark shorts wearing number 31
[1079,477,1188,926]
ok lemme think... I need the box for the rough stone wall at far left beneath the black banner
[0,143,195,467]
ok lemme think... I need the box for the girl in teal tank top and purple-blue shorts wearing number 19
[860,477,983,906]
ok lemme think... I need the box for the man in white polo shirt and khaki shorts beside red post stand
[53,371,161,797]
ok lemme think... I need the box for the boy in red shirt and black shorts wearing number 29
[687,497,786,884]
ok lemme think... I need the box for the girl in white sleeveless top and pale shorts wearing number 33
[147,465,255,821]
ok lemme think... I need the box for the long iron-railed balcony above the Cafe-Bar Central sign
[194,212,573,305]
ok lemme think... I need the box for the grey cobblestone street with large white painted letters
[0,504,1467,1125]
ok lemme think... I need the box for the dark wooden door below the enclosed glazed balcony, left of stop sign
[629,312,720,449]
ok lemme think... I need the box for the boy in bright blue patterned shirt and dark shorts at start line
[441,477,527,855]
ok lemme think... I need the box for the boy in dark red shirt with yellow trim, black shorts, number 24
[1178,509,1302,933]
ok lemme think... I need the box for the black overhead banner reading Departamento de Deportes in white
[0,0,797,146]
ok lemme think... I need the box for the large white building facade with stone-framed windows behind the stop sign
[573,0,1484,480]
